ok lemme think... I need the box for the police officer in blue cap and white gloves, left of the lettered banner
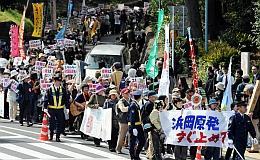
[128,91,145,160]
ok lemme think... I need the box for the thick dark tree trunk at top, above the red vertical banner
[185,0,202,38]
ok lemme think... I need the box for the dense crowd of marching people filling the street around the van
[1,5,260,160]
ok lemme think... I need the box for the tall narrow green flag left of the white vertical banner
[146,10,164,79]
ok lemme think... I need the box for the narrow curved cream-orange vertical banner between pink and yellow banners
[18,0,29,59]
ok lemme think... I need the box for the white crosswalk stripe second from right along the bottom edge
[29,143,92,159]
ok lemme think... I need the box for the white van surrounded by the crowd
[85,44,128,78]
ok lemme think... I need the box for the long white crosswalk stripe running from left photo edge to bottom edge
[0,144,57,159]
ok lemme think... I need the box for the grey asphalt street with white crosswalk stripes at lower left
[0,119,139,160]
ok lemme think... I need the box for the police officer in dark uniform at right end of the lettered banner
[228,102,258,159]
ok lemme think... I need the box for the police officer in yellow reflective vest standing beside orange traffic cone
[44,74,69,142]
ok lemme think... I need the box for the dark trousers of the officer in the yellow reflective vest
[48,108,65,137]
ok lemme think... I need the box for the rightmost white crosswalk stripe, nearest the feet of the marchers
[64,143,126,160]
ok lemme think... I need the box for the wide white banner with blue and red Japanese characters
[160,110,234,148]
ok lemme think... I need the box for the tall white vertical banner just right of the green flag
[158,24,170,96]
